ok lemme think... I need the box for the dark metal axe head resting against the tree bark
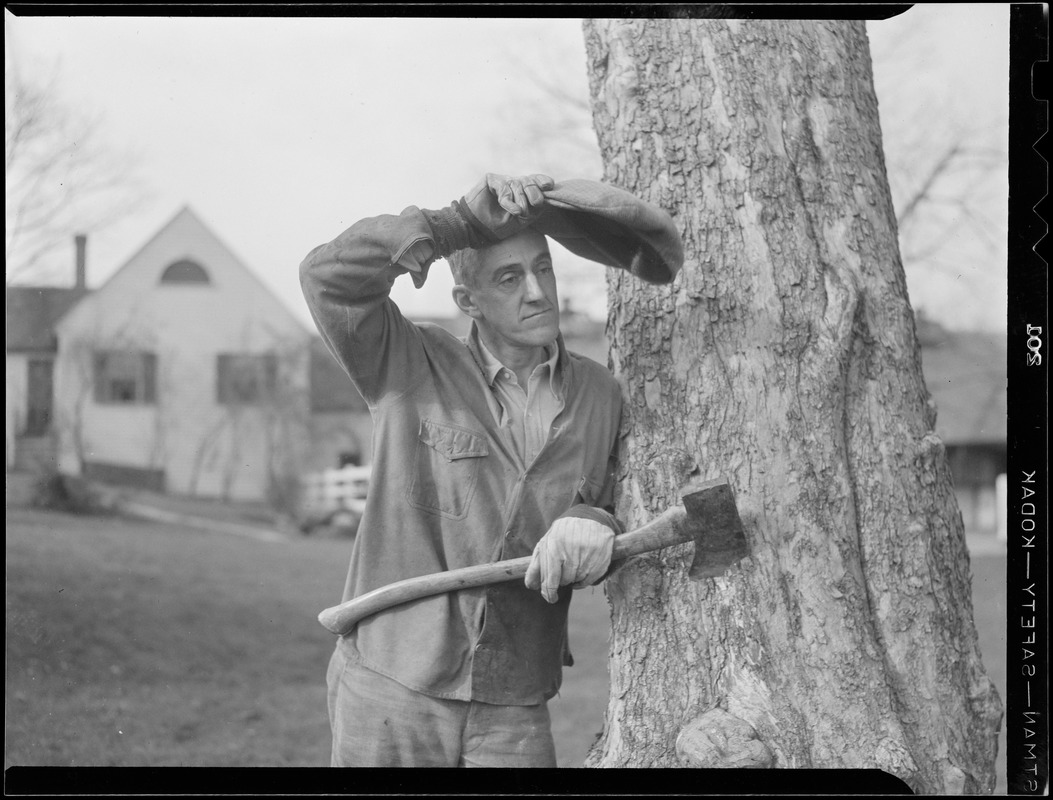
[680,480,750,580]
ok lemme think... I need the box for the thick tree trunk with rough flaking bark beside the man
[584,20,1001,793]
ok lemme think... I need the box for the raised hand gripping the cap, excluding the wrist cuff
[457,173,556,243]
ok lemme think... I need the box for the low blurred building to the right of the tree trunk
[918,318,1008,539]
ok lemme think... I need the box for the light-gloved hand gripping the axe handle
[525,517,614,603]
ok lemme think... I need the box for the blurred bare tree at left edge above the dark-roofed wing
[4,49,145,284]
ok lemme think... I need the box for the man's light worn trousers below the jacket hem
[326,646,556,767]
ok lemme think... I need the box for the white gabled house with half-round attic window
[53,207,312,500]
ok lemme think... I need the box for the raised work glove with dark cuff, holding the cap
[421,173,556,256]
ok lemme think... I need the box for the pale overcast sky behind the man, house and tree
[4,4,1009,331]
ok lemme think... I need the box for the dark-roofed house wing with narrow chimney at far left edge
[5,236,88,472]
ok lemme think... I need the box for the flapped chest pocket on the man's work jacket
[410,419,490,519]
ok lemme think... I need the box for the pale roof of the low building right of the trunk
[921,328,1009,445]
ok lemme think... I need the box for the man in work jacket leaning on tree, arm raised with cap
[301,175,678,766]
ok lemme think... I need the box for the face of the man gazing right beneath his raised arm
[458,229,559,347]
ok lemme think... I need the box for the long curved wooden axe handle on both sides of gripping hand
[318,505,696,636]
